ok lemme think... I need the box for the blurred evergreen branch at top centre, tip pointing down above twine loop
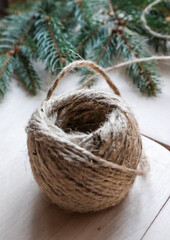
[66,0,104,51]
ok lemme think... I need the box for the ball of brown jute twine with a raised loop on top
[27,61,148,212]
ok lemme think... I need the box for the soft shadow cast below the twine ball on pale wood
[29,190,140,240]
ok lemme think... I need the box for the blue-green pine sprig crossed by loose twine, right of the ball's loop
[118,31,159,95]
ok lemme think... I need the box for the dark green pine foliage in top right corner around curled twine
[110,0,170,53]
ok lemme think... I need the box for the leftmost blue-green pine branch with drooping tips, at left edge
[0,14,39,96]
